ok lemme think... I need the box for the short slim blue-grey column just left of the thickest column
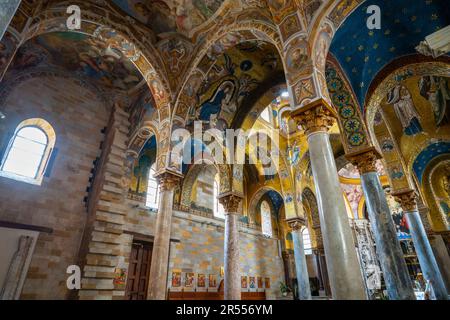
[287,218,312,300]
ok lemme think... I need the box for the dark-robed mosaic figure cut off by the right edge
[419,76,450,127]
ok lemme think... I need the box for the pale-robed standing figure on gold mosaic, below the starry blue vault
[387,84,423,136]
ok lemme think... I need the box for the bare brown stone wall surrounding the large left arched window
[0,77,109,299]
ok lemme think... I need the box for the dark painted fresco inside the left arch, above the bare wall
[12,32,143,90]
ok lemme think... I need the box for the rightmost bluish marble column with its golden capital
[393,190,448,300]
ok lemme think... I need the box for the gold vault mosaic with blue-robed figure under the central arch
[188,41,282,130]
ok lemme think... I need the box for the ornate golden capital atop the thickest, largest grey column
[292,99,336,136]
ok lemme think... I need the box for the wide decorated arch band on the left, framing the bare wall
[16,1,172,174]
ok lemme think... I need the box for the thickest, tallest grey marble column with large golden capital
[292,99,367,300]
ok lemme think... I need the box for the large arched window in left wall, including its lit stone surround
[0,119,55,185]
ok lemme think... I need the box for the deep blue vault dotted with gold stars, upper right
[330,0,450,107]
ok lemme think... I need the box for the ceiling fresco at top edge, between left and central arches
[113,0,224,35]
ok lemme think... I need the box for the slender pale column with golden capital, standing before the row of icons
[219,194,242,300]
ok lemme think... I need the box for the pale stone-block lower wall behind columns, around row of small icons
[125,209,284,299]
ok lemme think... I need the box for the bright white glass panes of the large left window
[2,127,48,179]
